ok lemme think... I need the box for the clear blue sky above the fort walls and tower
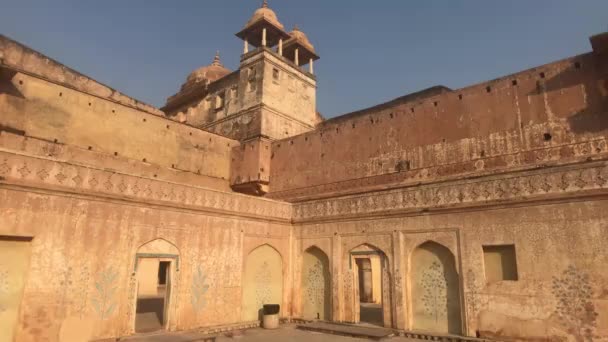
[0,0,608,117]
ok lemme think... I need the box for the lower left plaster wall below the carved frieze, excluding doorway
[1,190,289,341]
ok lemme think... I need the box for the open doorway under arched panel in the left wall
[135,239,179,332]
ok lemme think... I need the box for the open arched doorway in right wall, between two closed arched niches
[350,244,392,327]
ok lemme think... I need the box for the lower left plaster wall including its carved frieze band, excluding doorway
[0,148,290,341]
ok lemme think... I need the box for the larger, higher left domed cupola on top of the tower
[236,0,289,53]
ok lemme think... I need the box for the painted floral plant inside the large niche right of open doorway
[420,261,448,322]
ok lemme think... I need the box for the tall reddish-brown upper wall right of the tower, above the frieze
[270,53,608,200]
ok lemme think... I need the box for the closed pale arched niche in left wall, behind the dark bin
[242,245,283,321]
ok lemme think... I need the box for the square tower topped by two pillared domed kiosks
[236,1,319,140]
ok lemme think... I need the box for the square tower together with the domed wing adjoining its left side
[163,1,319,141]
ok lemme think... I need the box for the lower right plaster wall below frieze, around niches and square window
[295,186,608,341]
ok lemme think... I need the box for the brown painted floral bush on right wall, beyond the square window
[552,265,598,342]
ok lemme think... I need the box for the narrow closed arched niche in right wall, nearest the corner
[300,247,331,320]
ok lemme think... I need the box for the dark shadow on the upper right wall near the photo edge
[529,61,608,134]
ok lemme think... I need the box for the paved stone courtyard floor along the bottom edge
[128,325,417,342]
